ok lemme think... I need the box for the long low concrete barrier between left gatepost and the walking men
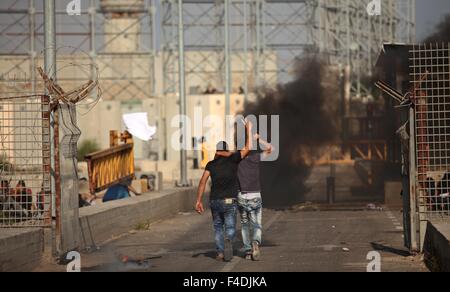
[80,188,196,248]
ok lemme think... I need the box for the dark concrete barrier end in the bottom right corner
[424,222,450,272]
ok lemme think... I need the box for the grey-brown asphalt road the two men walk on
[37,206,427,272]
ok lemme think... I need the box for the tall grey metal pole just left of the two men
[178,0,189,187]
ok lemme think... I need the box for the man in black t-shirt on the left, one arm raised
[195,123,252,261]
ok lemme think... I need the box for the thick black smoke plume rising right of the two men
[245,59,339,207]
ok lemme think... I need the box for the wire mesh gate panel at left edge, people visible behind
[0,96,52,227]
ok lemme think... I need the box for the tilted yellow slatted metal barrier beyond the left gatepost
[85,131,134,194]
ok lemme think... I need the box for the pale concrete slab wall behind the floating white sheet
[77,94,244,170]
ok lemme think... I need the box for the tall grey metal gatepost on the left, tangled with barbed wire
[44,0,79,257]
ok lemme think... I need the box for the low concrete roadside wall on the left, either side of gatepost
[0,188,196,272]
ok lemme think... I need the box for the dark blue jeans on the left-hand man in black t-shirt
[209,199,237,253]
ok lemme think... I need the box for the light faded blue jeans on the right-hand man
[238,198,262,252]
